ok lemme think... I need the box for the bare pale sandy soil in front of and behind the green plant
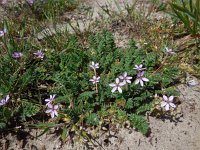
[0,1,200,150]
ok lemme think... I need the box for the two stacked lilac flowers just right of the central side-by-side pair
[134,64,149,86]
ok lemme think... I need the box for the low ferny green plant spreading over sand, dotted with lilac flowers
[0,16,178,137]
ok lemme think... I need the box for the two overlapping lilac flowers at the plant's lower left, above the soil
[45,94,58,118]
